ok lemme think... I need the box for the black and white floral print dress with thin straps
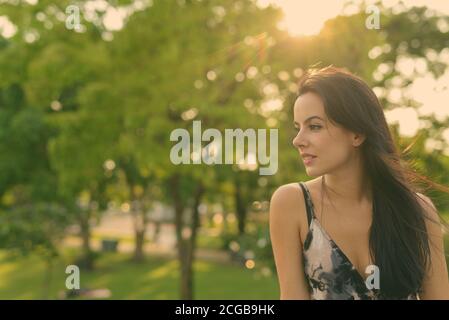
[299,182,419,300]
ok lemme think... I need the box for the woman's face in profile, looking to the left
[293,92,360,177]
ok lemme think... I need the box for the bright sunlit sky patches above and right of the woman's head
[266,0,449,154]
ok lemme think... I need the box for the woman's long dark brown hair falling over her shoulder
[298,66,446,299]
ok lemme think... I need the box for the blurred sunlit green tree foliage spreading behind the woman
[0,0,449,297]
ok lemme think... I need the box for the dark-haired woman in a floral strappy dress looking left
[270,67,449,299]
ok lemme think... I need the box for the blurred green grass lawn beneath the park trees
[0,251,279,300]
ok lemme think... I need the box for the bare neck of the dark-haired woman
[323,152,372,203]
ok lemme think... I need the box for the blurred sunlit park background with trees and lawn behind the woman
[0,0,449,299]
